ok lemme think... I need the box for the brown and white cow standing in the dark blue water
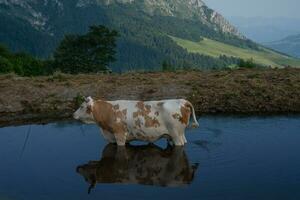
[73,97,199,146]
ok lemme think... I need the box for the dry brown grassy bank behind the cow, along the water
[0,68,300,126]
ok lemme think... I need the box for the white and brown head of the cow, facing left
[73,97,95,124]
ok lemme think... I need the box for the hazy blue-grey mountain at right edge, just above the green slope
[265,34,300,58]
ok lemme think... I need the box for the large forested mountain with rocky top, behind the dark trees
[0,0,298,71]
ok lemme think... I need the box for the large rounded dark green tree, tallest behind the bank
[54,25,118,74]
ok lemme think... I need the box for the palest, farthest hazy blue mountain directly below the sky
[228,17,300,43]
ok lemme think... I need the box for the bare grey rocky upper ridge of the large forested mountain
[0,0,244,38]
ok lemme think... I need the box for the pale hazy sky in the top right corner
[204,0,300,18]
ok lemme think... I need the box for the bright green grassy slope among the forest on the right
[171,37,300,67]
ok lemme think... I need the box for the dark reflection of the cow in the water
[77,144,198,192]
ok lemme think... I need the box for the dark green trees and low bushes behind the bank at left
[0,26,118,76]
